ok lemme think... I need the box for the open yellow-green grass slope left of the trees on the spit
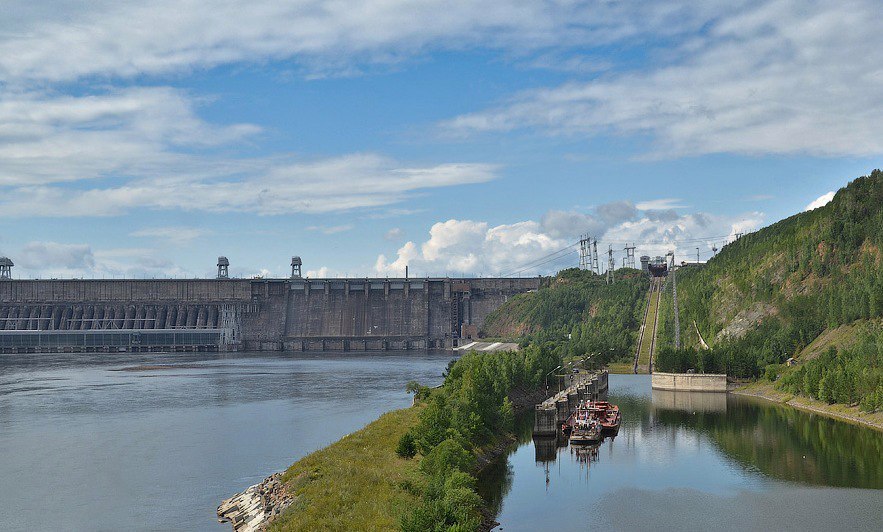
[270,406,424,531]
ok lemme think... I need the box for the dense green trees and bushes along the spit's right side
[396,345,560,532]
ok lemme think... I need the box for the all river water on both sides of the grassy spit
[0,360,883,531]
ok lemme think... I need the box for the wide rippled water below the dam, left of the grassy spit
[0,352,450,530]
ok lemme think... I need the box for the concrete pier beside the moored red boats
[533,370,608,436]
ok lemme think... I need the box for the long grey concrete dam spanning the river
[0,277,542,353]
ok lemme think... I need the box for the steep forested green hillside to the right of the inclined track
[657,170,883,408]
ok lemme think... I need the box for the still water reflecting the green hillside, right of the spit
[480,375,883,531]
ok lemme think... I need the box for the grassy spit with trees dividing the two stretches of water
[271,346,561,532]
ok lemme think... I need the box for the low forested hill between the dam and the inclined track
[482,268,648,363]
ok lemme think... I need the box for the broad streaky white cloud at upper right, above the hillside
[443,0,883,157]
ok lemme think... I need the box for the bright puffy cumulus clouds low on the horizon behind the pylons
[374,208,763,277]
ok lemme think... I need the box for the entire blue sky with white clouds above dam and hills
[0,0,883,278]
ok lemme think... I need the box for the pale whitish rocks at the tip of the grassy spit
[218,473,294,532]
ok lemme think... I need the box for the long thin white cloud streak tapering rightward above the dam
[0,154,497,217]
